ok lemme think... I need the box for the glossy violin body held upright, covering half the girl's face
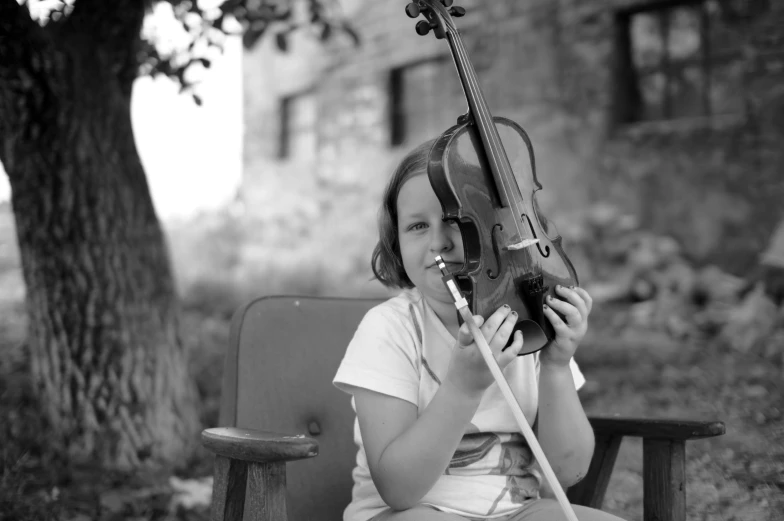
[428,117,578,355]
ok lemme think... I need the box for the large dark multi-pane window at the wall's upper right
[614,0,743,124]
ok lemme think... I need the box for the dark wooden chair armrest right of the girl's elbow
[588,416,725,440]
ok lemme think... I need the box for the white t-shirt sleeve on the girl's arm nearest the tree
[332,305,421,405]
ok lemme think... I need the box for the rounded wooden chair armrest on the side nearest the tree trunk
[201,427,318,463]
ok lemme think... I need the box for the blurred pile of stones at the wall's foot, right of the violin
[569,201,784,365]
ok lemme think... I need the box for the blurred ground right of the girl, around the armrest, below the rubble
[576,304,784,521]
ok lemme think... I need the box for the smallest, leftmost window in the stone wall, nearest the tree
[278,93,316,160]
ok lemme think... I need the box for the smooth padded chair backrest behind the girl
[220,296,381,521]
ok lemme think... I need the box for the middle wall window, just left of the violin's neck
[389,57,465,146]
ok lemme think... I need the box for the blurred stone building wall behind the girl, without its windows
[242,0,784,293]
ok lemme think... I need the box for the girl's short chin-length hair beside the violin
[370,139,436,289]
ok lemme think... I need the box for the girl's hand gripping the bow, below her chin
[446,305,523,397]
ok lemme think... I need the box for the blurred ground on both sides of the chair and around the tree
[0,300,784,521]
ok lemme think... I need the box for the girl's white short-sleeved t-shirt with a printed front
[333,289,585,521]
